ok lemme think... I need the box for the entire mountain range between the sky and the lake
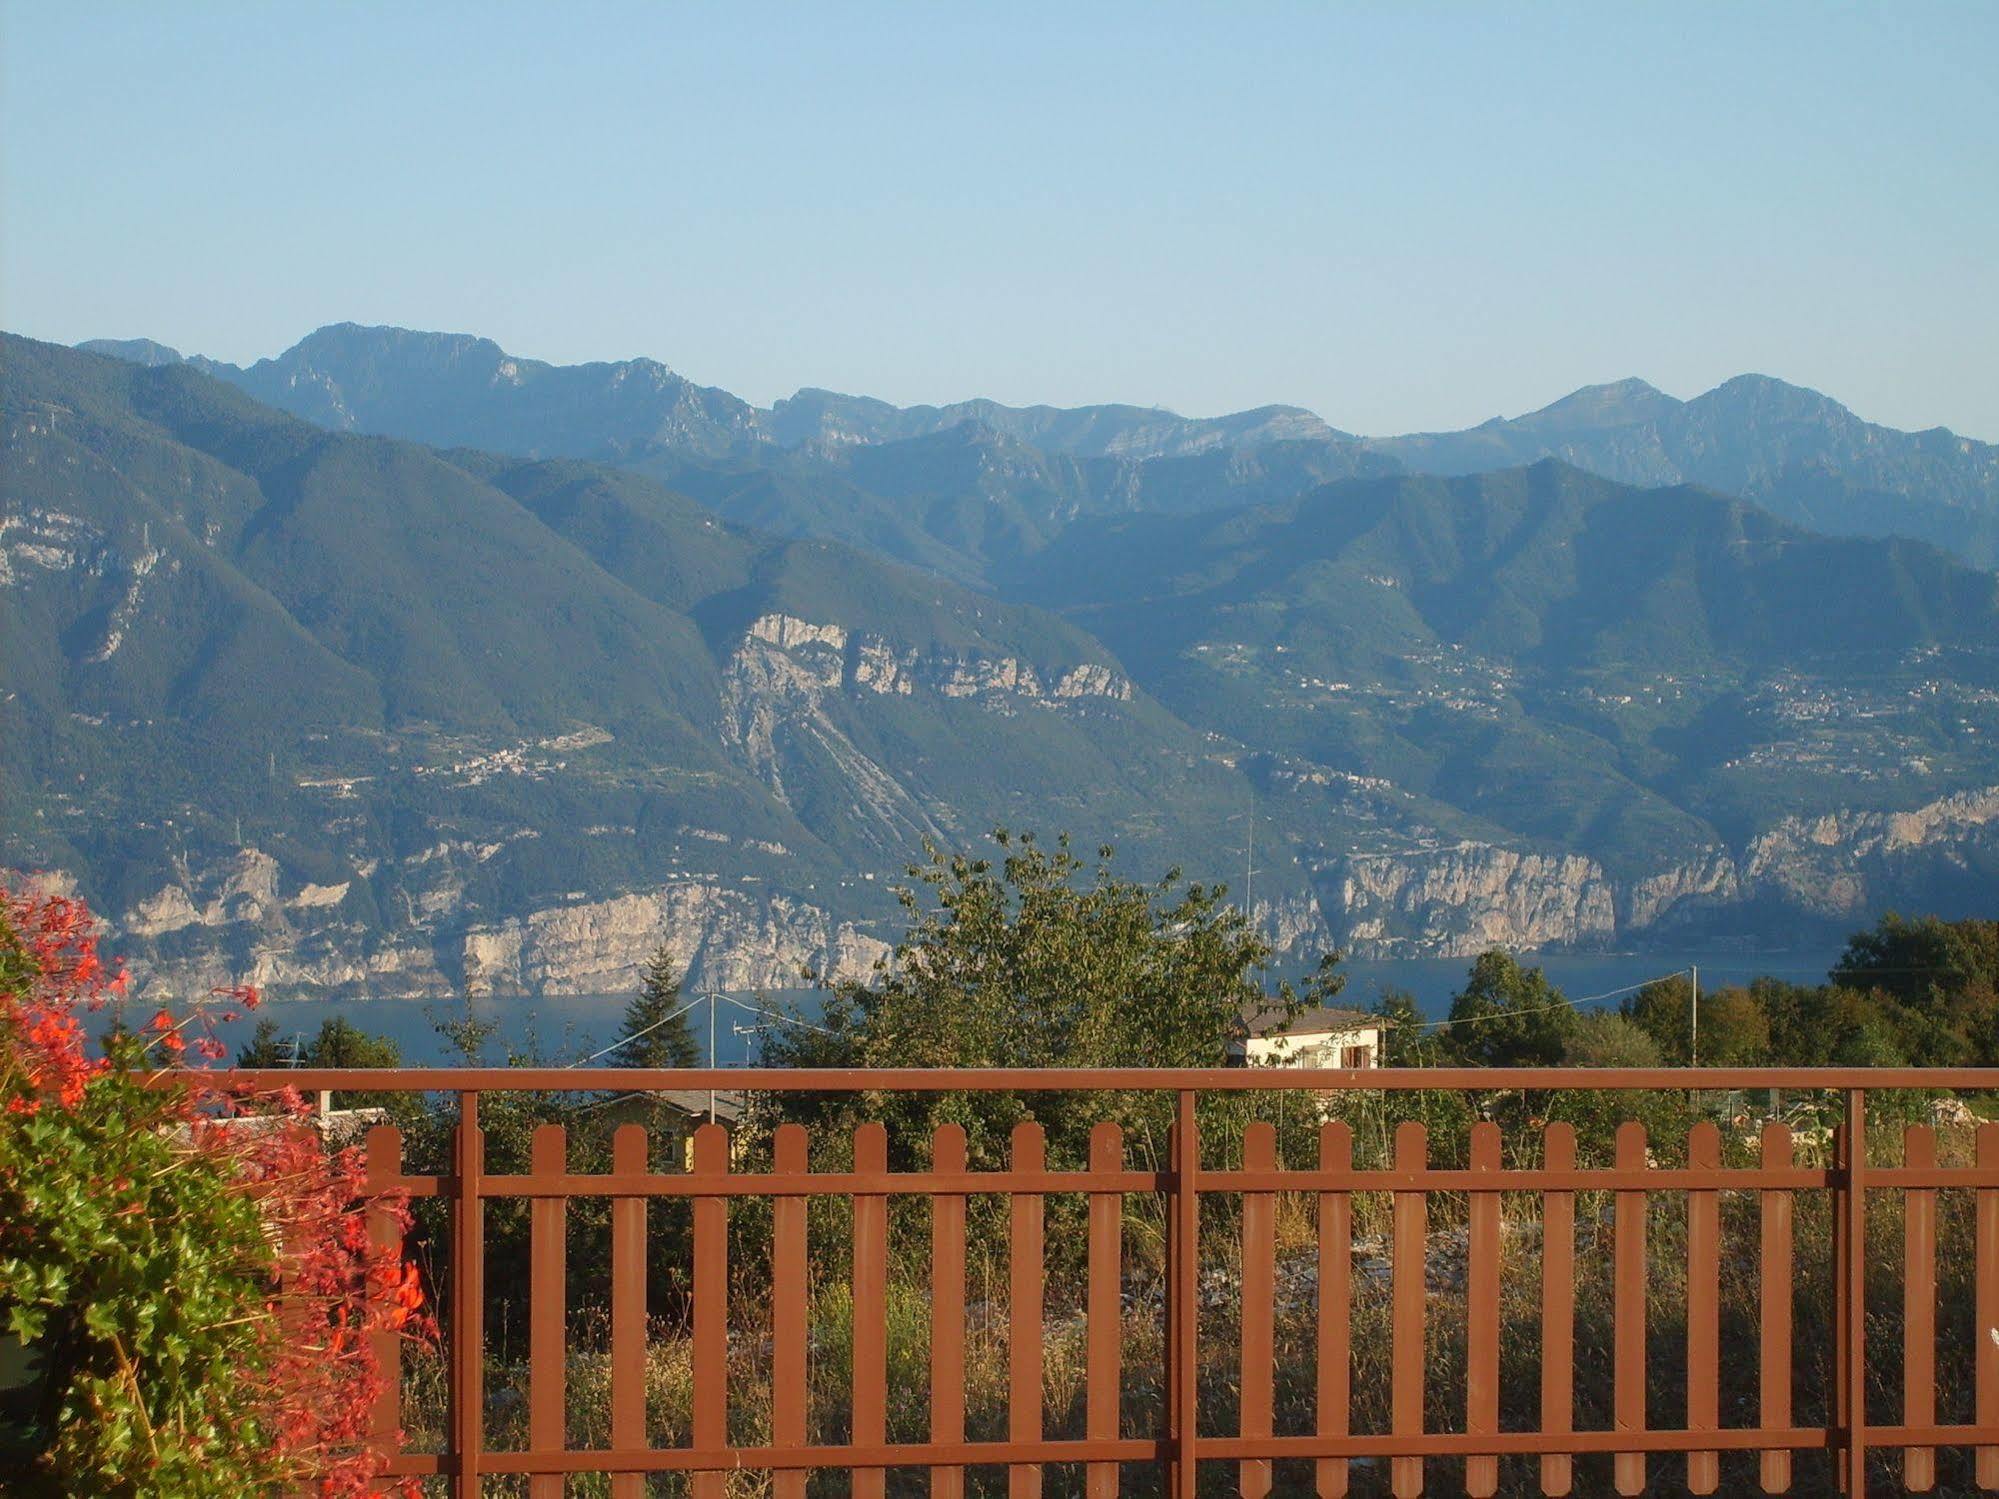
[0,324,1999,993]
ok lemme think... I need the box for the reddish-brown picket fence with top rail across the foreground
[210,1069,1999,1499]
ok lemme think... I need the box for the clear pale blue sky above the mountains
[0,0,1999,438]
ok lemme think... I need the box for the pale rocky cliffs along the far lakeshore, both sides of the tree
[58,779,1999,997]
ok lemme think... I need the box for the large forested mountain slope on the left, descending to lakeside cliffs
[0,338,1279,987]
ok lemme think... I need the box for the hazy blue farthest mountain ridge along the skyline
[84,324,1999,580]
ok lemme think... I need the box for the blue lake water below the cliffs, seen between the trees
[98,945,1841,1067]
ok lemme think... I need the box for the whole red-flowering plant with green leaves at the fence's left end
[0,887,430,1499]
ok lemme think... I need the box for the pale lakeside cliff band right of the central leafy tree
[1317,787,1999,957]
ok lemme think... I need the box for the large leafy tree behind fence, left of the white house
[766,829,1343,1167]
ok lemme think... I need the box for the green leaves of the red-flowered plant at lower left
[0,1041,276,1499]
